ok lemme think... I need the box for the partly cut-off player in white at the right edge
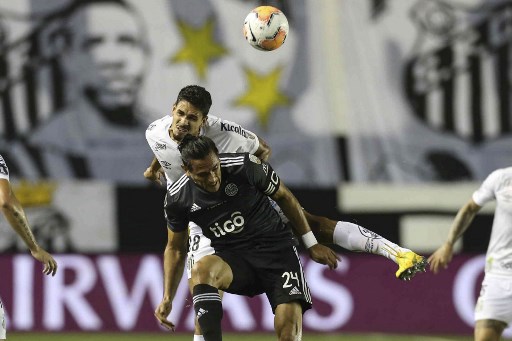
[429,167,512,341]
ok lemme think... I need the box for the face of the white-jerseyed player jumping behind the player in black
[169,101,206,141]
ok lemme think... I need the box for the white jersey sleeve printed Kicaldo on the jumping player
[205,115,260,154]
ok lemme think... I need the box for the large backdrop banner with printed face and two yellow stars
[0,0,340,187]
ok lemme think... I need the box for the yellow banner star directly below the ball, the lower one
[235,67,290,128]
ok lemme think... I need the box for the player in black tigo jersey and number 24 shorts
[165,135,339,341]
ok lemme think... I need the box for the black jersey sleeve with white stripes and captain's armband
[245,154,281,197]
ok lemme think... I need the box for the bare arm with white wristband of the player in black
[271,179,340,269]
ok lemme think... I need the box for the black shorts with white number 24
[216,246,312,313]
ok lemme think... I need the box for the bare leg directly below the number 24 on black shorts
[274,301,302,341]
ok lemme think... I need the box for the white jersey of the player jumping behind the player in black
[146,115,260,236]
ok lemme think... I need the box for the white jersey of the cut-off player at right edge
[473,167,512,275]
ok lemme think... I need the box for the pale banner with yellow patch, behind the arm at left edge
[0,181,118,253]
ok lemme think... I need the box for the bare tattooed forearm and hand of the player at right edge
[428,199,482,273]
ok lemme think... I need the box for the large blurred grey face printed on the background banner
[61,0,148,124]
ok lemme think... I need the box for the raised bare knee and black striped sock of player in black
[191,255,233,341]
